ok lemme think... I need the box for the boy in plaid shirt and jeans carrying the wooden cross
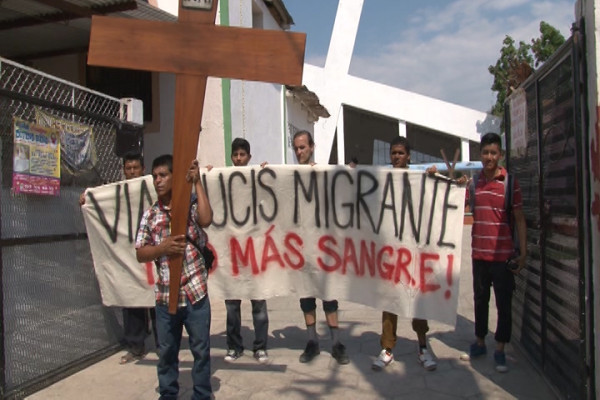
[135,154,212,400]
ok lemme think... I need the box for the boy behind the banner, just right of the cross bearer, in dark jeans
[225,138,269,364]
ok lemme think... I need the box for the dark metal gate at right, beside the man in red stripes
[505,29,593,399]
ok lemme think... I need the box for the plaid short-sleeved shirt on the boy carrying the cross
[135,201,208,307]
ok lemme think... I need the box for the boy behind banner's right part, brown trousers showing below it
[372,136,437,371]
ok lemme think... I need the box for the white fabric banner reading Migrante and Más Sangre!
[84,165,465,325]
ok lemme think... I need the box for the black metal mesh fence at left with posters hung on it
[0,58,129,399]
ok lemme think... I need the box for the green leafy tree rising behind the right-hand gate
[488,21,565,117]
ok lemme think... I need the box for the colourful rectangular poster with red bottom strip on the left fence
[12,118,60,196]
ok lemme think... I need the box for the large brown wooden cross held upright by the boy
[88,0,306,314]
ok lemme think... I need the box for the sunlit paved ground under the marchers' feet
[27,226,557,400]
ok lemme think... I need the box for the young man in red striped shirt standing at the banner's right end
[461,133,527,372]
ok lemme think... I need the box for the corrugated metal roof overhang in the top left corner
[0,0,177,61]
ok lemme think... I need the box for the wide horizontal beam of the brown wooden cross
[88,16,306,86]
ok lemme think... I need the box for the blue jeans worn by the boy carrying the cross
[156,295,212,400]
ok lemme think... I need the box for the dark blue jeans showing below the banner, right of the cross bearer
[225,300,269,352]
